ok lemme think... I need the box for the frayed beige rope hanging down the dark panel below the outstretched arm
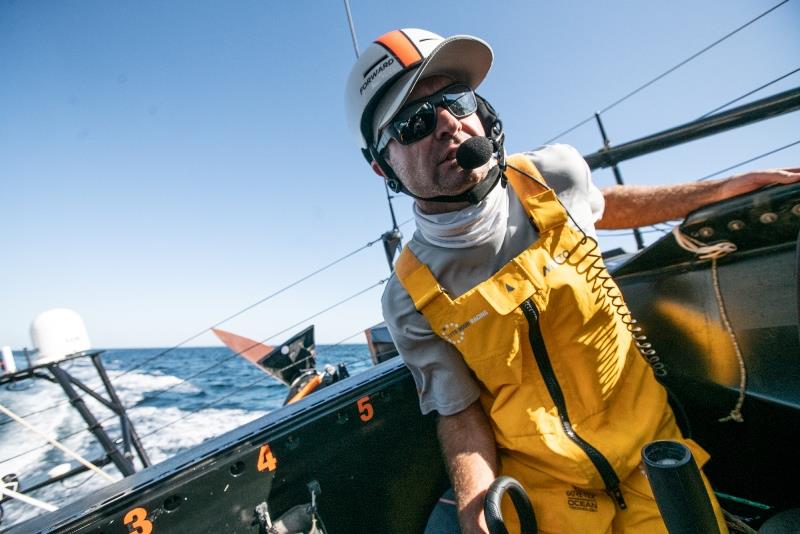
[672,227,747,423]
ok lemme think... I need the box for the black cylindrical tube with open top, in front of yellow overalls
[642,441,719,534]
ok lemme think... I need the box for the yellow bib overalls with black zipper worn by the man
[396,155,727,534]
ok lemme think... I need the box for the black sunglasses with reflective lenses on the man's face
[375,83,478,153]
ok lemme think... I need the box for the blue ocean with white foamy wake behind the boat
[0,344,372,529]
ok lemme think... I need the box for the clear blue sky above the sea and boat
[0,0,800,348]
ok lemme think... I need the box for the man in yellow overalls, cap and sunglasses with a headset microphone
[346,29,800,532]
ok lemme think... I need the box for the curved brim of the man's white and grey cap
[372,35,493,139]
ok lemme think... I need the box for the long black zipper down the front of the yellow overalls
[520,299,628,510]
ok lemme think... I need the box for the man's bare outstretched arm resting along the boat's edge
[596,168,800,230]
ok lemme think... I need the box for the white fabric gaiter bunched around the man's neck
[414,184,508,248]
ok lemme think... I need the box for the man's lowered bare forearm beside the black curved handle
[438,401,497,534]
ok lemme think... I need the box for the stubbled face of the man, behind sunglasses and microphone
[387,76,489,212]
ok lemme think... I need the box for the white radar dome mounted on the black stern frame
[31,308,92,365]
